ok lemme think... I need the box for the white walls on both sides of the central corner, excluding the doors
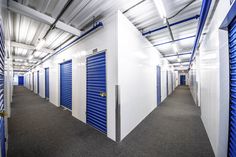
[24,12,177,140]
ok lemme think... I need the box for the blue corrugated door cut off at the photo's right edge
[228,18,236,157]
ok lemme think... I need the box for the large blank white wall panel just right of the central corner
[118,12,171,139]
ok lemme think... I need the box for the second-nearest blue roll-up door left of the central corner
[60,60,72,110]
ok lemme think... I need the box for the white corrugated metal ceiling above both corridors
[2,0,204,70]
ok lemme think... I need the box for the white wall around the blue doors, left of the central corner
[29,11,117,140]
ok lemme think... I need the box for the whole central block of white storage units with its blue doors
[24,12,178,141]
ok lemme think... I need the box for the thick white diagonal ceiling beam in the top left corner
[3,0,81,36]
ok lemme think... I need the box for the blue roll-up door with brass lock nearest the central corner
[86,52,107,134]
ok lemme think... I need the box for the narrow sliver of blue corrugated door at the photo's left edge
[0,21,6,157]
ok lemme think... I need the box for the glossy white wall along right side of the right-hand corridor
[191,0,230,157]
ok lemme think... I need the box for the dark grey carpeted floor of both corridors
[8,87,214,157]
